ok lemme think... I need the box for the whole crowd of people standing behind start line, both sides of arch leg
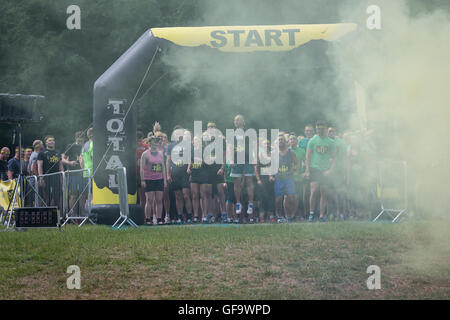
[0,115,376,225]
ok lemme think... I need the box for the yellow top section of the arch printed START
[151,23,356,52]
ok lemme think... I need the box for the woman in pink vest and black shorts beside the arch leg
[141,136,167,224]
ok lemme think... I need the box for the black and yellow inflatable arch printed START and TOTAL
[93,23,356,224]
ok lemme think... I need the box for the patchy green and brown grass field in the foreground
[0,220,450,299]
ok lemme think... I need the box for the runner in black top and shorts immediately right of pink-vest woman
[166,126,192,223]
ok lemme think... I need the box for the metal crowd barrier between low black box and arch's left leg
[63,169,95,227]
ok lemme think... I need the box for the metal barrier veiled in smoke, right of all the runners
[373,160,408,222]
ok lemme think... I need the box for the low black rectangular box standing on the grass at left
[14,207,59,228]
